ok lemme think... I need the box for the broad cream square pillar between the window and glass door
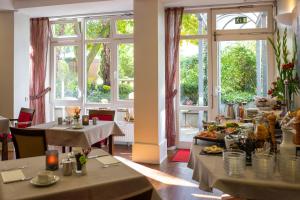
[132,0,167,164]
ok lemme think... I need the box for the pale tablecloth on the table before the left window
[30,121,124,147]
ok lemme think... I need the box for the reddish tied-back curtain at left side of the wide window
[29,18,50,124]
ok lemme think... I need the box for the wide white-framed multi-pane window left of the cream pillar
[51,15,134,119]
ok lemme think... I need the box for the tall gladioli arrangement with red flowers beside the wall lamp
[268,29,300,101]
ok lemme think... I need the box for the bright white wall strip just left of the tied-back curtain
[14,12,30,117]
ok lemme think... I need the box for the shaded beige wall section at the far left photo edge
[0,11,14,118]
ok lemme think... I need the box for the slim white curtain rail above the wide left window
[49,11,133,20]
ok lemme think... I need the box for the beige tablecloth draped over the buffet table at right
[188,143,300,200]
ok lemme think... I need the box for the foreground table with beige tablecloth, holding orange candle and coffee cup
[0,149,161,200]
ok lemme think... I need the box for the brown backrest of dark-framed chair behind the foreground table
[10,127,48,159]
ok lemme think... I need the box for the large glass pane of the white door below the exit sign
[217,40,268,115]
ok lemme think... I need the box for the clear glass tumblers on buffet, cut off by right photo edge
[279,155,300,183]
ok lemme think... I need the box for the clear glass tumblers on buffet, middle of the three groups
[252,153,275,179]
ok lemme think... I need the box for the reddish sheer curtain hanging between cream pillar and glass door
[165,8,183,147]
